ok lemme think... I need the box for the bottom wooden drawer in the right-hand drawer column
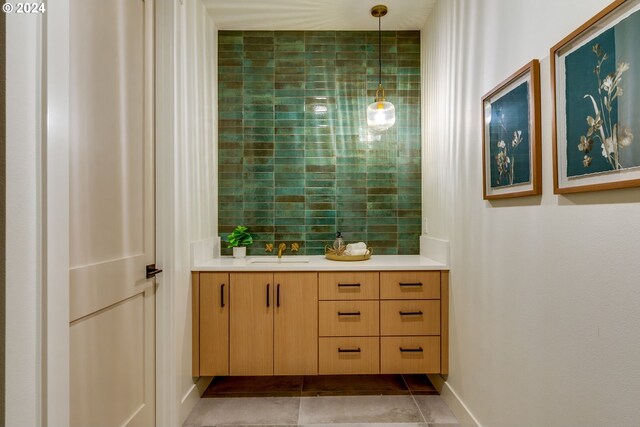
[380,337,440,374]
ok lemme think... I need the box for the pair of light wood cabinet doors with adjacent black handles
[229,272,318,375]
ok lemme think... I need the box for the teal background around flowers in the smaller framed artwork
[489,82,531,188]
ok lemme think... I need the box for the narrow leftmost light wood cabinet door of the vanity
[200,273,229,376]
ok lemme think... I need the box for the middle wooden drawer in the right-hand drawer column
[380,300,440,335]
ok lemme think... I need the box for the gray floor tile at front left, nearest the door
[184,397,300,427]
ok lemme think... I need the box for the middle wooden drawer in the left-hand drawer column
[319,301,380,337]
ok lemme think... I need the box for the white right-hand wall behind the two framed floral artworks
[423,0,640,427]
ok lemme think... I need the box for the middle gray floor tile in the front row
[299,396,424,425]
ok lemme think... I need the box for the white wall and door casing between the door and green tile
[156,0,217,426]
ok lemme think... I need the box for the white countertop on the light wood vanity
[191,255,449,271]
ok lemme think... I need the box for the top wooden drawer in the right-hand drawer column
[380,271,440,299]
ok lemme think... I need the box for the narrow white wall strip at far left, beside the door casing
[5,10,42,426]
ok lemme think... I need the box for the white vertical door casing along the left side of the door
[43,0,70,427]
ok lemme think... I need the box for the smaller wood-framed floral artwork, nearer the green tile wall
[482,59,542,200]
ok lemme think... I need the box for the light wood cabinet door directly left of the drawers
[273,273,318,375]
